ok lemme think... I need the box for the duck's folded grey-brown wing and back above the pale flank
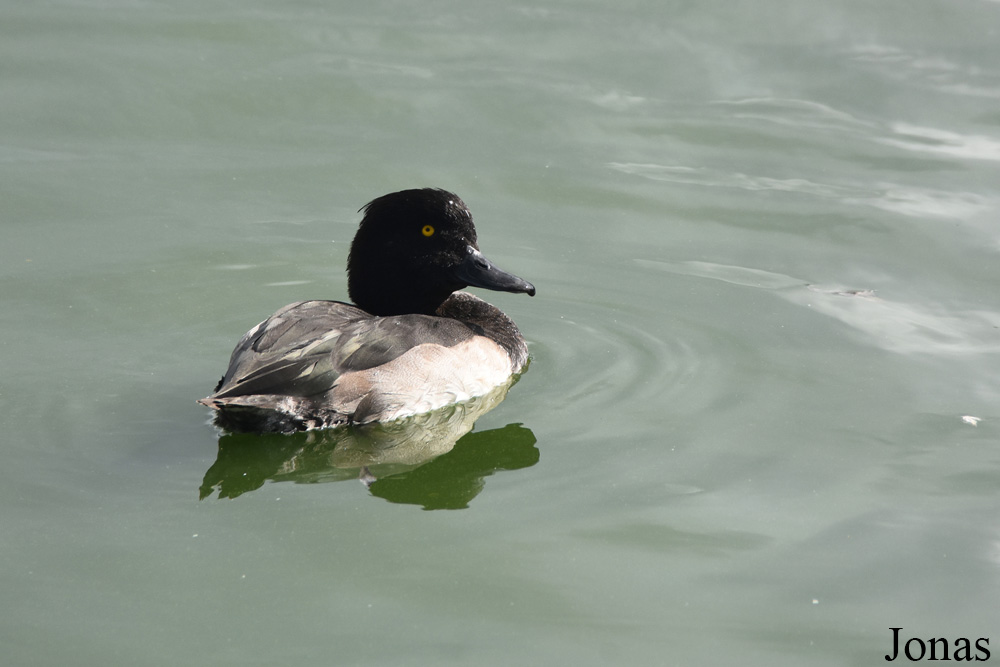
[210,301,474,399]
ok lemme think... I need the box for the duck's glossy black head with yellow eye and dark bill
[347,188,535,315]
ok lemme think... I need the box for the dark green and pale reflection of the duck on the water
[200,385,539,509]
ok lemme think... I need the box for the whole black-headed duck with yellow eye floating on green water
[198,188,535,432]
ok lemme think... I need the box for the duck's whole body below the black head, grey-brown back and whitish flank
[200,293,527,431]
